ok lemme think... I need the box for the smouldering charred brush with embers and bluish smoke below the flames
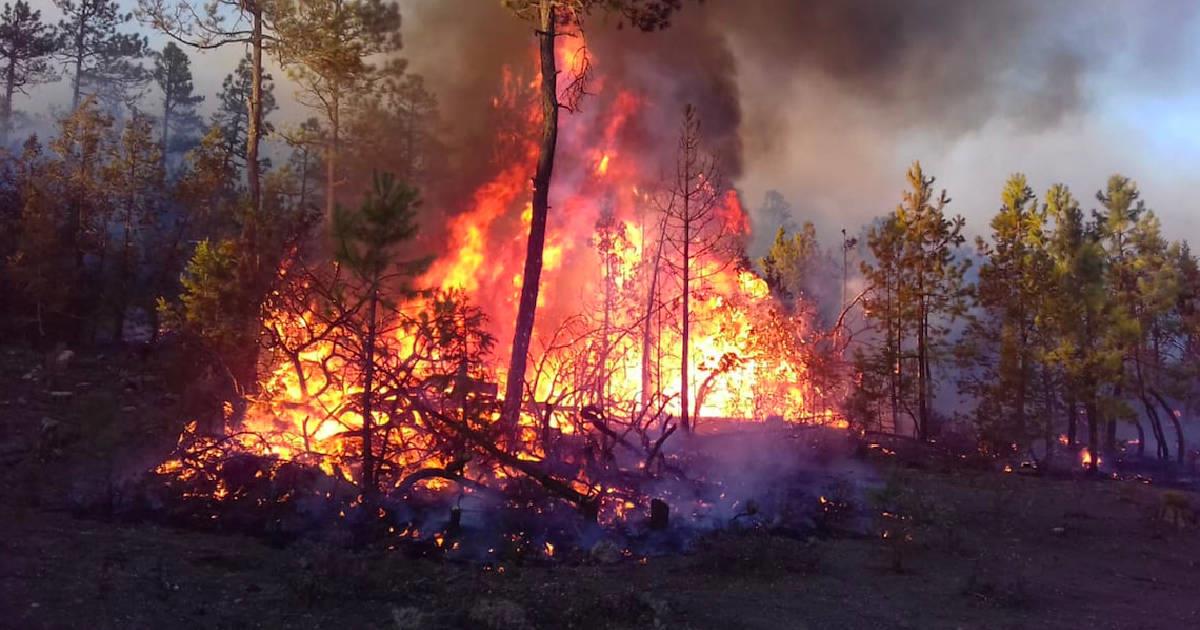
[120,422,881,564]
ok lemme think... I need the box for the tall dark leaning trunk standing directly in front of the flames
[502,1,558,430]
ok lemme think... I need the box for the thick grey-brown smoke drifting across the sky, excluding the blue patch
[402,0,1200,250]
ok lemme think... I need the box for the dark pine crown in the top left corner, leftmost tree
[0,0,59,144]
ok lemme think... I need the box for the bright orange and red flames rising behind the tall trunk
[160,30,845,510]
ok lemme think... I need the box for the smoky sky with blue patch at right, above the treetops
[16,0,1200,250]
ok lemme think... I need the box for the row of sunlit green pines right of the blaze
[758,163,1200,463]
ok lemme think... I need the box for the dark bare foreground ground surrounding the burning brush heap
[0,352,1200,629]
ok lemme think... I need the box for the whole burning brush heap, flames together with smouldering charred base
[128,27,863,558]
